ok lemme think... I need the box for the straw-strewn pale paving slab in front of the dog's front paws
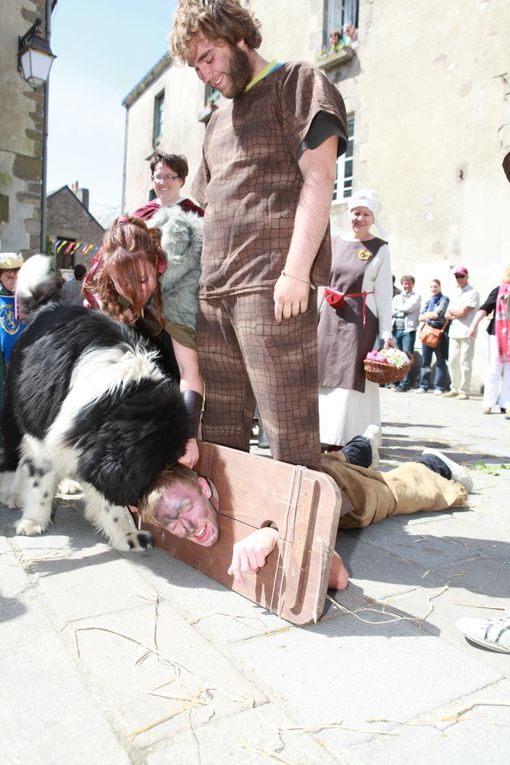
[58,593,267,747]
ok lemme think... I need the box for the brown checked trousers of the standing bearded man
[198,291,320,469]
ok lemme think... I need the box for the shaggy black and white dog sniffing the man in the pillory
[0,255,190,550]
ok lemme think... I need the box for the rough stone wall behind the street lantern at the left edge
[0,0,46,254]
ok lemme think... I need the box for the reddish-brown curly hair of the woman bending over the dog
[94,215,166,326]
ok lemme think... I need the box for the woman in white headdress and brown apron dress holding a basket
[318,189,393,460]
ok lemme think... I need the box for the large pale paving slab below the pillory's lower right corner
[231,613,501,752]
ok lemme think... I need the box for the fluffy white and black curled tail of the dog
[16,255,64,317]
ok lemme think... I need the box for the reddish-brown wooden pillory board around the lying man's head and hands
[144,443,341,624]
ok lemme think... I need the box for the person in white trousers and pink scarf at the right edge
[468,266,510,414]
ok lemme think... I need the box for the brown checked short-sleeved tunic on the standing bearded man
[192,61,346,297]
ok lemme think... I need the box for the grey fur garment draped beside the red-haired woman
[148,205,202,329]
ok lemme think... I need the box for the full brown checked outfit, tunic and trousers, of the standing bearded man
[192,62,346,469]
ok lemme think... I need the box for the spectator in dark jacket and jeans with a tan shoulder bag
[416,279,450,396]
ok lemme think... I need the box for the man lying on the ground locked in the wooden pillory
[138,428,473,590]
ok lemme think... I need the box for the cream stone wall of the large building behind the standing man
[122,0,510,389]
